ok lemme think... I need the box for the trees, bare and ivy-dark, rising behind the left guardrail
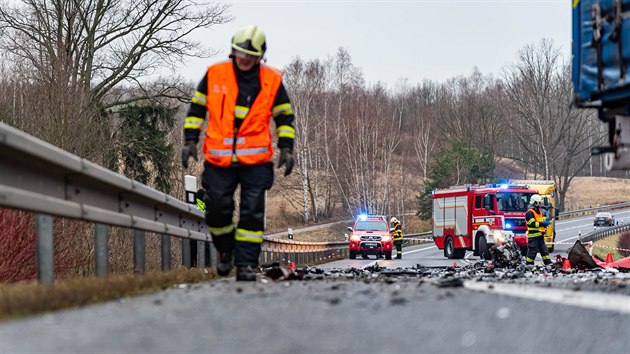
[0,0,231,193]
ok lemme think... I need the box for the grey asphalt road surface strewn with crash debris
[0,212,630,353]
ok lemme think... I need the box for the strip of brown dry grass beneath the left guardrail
[0,268,217,321]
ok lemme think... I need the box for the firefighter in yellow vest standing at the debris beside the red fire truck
[525,194,551,265]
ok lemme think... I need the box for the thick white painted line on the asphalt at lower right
[464,280,630,314]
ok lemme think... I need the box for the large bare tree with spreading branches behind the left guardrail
[0,0,230,163]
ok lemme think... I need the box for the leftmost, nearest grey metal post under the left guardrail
[35,214,55,285]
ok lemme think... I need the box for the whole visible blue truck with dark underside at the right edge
[571,0,630,171]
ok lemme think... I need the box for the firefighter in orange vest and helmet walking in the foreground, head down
[182,26,295,281]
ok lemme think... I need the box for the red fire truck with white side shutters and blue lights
[433,184,536,259]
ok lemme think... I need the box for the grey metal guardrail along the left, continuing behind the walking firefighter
[0,122,348,284]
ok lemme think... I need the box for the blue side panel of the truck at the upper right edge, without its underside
[571,0,630,108]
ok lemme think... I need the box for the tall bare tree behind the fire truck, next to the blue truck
[504,39,601,208]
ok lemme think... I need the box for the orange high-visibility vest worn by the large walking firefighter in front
[203,61,282,167]
